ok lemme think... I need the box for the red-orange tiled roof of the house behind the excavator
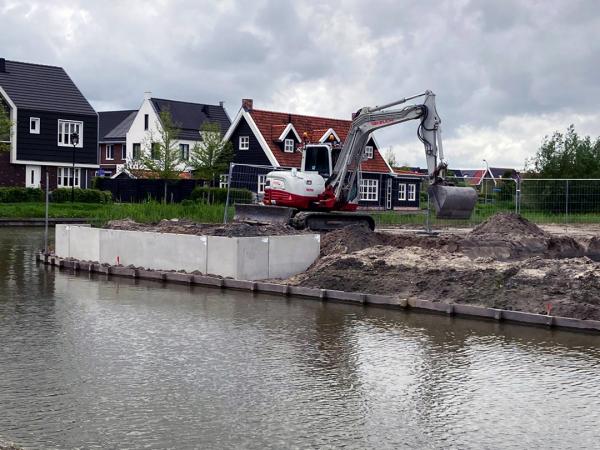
[249,109,390,173]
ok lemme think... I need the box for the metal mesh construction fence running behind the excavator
[220,163,600,230]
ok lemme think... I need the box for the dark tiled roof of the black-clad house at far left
[0,61,96,115]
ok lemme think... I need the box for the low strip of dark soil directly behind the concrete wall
[106,219,302,237]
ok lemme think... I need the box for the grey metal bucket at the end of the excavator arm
[428,184,477,219]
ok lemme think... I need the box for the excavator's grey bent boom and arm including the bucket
[321,91,477,219]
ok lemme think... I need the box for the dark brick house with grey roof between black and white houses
[98,110,137,177]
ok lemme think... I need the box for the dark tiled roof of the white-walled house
[151,98,231,141]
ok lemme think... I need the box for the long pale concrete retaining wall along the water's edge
[55,225,321,280]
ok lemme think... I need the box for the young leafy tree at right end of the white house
[189,122,233,184]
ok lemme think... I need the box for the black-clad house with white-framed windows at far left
[0,58,98,189]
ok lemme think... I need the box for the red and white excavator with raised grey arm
[234,90,477,231]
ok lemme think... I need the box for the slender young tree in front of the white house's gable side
[125,111,184,202]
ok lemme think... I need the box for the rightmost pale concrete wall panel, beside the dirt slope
[264,234,321,278]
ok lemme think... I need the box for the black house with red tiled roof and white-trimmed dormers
[221,99,420,209]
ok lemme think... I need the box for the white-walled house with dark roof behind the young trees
[108,92,231,177]
